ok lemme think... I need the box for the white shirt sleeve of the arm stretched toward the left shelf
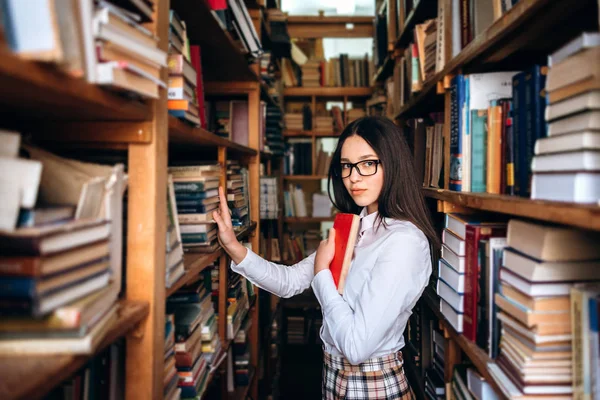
[231,250,316,297]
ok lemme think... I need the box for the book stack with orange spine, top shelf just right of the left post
[168,10,201,126]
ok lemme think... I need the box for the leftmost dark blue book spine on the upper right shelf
[450,75,465,192]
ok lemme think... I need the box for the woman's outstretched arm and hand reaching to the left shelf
[213,187,315,297]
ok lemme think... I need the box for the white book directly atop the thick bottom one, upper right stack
[531,150,600,172]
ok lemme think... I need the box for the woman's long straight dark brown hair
[327,117,439,249]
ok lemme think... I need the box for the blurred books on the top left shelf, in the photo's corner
[1,0,167,98]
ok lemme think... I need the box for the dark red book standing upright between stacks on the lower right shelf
[463,223,506,342]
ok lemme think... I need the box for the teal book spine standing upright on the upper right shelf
[471,110,487,193]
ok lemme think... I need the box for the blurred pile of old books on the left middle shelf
[0,132,125,355]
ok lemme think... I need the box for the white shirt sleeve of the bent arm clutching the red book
[312,232,431,364]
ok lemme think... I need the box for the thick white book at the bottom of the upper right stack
[531,172,600,203]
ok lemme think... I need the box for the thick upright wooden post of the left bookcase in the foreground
[125,1,169,400]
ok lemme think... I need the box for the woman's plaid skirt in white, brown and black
[322,351,415,400]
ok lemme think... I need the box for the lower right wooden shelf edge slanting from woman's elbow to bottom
[422,290,506,399]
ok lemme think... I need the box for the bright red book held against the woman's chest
[329,213,360,294]
